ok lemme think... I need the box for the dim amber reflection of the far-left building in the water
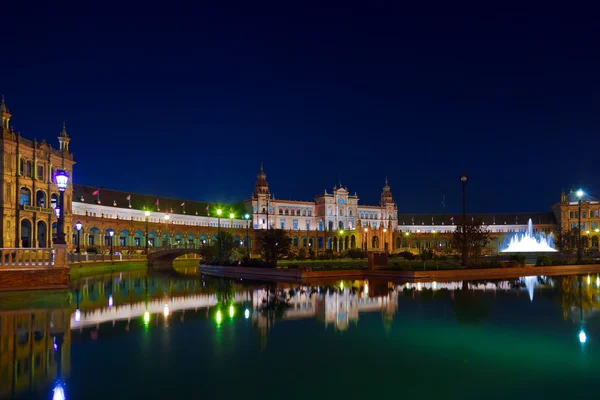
[0,310,71,398]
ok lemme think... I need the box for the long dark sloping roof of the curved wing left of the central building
[73,184,251,217]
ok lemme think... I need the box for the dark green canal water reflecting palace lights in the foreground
[0,269,600,399]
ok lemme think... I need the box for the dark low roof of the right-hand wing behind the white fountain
[398,211,556,227]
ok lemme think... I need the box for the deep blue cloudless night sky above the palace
[0,1,600,213]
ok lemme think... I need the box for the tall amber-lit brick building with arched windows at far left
[0,97,74,248]
